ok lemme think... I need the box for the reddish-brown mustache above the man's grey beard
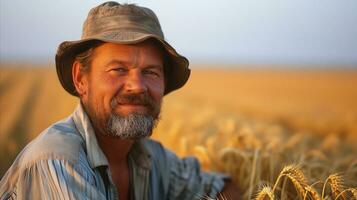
[110,93,157,111]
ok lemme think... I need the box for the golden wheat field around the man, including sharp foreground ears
[0,65,357,199]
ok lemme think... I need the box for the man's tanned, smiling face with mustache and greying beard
[81,42,164,139]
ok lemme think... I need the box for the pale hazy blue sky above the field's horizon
[0,0,357,68]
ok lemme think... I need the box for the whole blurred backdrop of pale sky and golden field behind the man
[0,0,357,197]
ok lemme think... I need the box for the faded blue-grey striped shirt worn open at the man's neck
[0,104,227,200]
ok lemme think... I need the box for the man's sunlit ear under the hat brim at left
[72,60,88,97]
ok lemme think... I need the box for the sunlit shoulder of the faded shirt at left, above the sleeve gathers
[15,117,84,168]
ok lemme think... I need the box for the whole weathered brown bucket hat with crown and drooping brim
[56,1,190,96]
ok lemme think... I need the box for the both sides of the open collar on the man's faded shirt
[72,103,151,169]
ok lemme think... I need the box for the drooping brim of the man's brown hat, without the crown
[56,31,190,96]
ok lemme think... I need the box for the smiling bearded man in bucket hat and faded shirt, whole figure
[0,2,237,200]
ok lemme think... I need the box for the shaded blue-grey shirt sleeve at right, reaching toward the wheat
[166,150,229,200]
